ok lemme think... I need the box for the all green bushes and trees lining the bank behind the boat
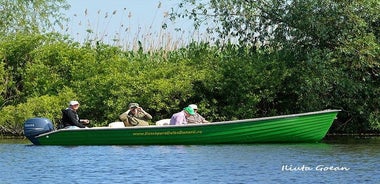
[0,0,380,135]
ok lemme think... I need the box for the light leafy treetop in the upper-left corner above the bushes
[0,0,70,36]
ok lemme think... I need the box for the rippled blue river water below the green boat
[0,137,380,184]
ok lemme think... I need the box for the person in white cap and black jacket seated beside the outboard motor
[62,100,90,128]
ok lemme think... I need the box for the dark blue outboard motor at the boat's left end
[24,118,54,145]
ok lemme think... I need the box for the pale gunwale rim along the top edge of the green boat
[36,109,341,138]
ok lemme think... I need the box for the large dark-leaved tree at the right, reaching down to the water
[171,0,380,131]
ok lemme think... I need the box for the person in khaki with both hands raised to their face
[119,103,152,126]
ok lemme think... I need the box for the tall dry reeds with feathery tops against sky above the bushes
[58,2,210,51]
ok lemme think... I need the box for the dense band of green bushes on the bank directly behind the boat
[0,34,379,134]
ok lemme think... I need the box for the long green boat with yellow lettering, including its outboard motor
[24,110,340,145]
